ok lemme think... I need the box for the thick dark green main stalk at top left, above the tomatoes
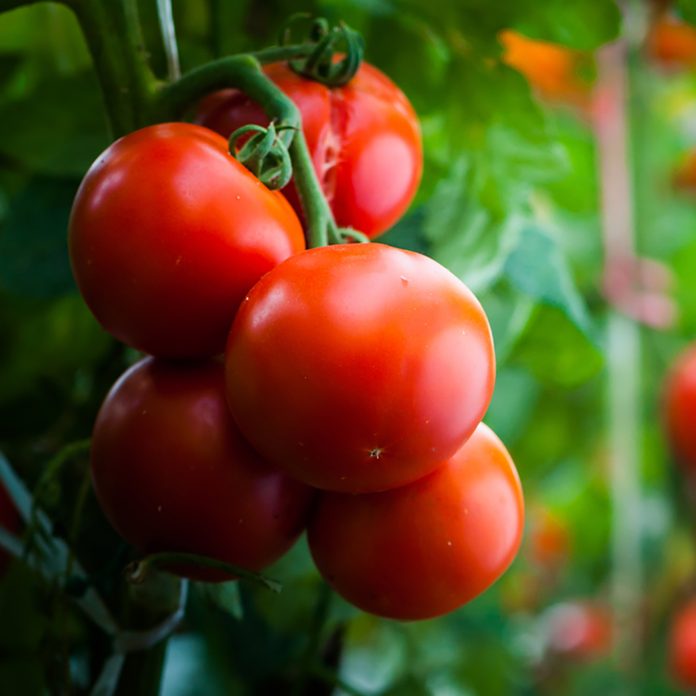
[70,0,157,137]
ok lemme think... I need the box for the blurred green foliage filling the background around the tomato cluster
[0,0,696,696]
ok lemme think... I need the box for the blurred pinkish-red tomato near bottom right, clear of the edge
[546,601,613,660]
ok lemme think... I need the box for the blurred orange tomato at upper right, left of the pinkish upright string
[499,29,590,107]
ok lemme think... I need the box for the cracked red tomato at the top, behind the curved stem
[196,63,423,237]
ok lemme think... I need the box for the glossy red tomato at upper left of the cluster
[69,123,304,358]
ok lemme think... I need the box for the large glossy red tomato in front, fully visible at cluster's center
[225,243,495,493]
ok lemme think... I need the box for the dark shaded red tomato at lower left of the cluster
[92,358,310,580]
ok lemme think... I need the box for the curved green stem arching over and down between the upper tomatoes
[157,55,341,247]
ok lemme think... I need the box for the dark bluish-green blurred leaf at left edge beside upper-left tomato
[0,177,78,298]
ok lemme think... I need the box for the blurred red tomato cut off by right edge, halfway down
[664,344,696,475]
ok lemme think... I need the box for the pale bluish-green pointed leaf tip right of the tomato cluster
[505,225,593,336]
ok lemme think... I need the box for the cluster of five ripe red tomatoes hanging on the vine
[69,57,523,619]
